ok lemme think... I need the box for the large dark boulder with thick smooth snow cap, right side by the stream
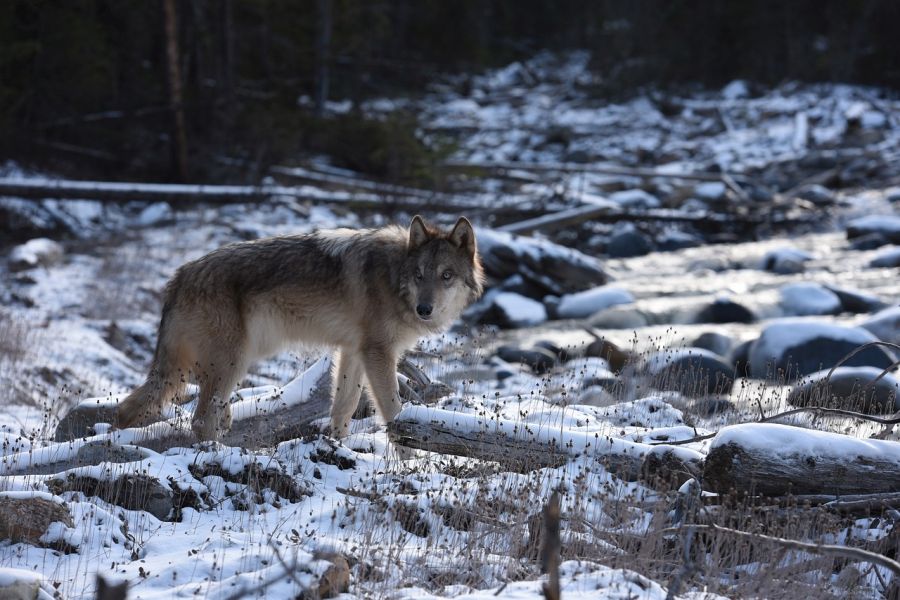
[749,319,896,382]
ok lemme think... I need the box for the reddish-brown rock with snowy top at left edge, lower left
[0,492,75,546]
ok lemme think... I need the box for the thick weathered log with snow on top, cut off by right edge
[703,423,900,496]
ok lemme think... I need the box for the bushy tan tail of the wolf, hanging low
[116,299,188,429]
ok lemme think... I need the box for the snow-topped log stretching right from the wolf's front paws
[388,406,651,481]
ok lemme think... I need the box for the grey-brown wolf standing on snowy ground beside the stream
[116,215,484,440]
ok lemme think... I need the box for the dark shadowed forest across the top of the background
[0,0,900,180]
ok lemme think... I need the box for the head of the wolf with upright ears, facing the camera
[403,215,484,329]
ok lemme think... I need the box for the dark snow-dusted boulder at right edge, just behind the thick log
[788,367,900,415]
